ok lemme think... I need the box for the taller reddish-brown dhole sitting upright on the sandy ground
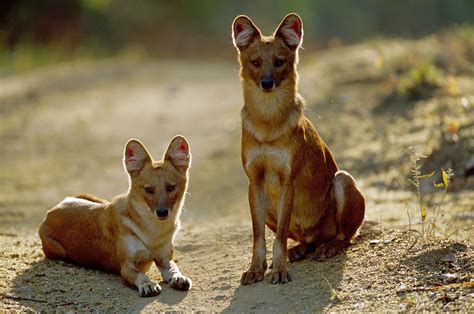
[233,14,365,284]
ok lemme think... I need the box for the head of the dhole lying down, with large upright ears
[124,136,191,220]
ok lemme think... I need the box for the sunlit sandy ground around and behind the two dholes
[0,37,474,312]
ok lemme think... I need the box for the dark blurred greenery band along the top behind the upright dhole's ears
[0,0,474,68]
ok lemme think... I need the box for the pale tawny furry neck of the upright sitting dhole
[241,73,304,142]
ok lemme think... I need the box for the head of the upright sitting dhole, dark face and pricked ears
[232,13,303,93]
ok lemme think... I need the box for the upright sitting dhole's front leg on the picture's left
[240,180,267,285]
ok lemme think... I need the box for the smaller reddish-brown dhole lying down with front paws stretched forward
[39,136,192,297]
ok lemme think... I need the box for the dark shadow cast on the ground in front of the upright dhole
[224,222,384,313]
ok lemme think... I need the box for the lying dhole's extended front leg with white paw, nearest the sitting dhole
[155,243,192,291]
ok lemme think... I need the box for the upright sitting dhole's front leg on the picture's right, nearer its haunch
[271,180,294,284]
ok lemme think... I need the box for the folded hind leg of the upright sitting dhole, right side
[314,170,365,260]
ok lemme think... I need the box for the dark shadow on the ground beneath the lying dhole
[8,259,187,312]
